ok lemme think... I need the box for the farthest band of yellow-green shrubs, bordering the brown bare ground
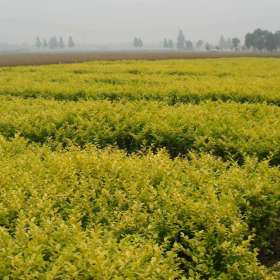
[0,59,280,105]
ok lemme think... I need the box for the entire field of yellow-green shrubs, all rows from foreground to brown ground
[0,58,280,280]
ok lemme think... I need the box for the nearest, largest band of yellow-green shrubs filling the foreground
[0,138,280,280]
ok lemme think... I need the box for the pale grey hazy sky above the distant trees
[0,0,280,44]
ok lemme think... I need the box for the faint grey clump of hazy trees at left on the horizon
[35,36,75,50]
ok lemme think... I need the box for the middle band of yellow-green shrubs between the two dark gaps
[0,98,280,165]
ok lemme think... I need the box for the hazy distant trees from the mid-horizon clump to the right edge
[133,29,280,51]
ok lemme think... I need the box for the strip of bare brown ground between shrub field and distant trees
[0,51,280,67]
